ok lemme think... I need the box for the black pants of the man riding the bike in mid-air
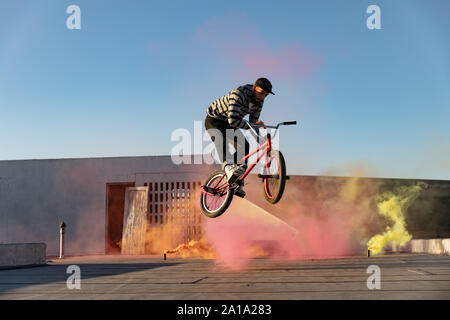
[205,116,250,164]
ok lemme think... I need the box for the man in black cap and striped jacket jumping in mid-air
[205,78,274,198]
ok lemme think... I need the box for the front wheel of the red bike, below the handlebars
[263,150,286,204]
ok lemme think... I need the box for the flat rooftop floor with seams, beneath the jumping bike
[0,254,450,300]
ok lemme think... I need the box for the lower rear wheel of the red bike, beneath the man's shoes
[200,170,234,218]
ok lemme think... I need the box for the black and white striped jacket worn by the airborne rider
[206,84,264,129]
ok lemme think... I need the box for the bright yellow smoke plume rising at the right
[367,185,421,254]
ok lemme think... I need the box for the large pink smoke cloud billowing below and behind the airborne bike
[202,176,376,270]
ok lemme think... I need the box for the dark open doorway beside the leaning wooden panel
[105,182,134,254]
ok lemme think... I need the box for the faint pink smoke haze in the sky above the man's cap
[192,14,322,82]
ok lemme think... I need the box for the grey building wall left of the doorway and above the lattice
[0,156,218,255]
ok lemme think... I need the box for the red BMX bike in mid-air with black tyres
[200,119,297,218]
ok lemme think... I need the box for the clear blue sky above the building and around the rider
[0,0,450,179]
